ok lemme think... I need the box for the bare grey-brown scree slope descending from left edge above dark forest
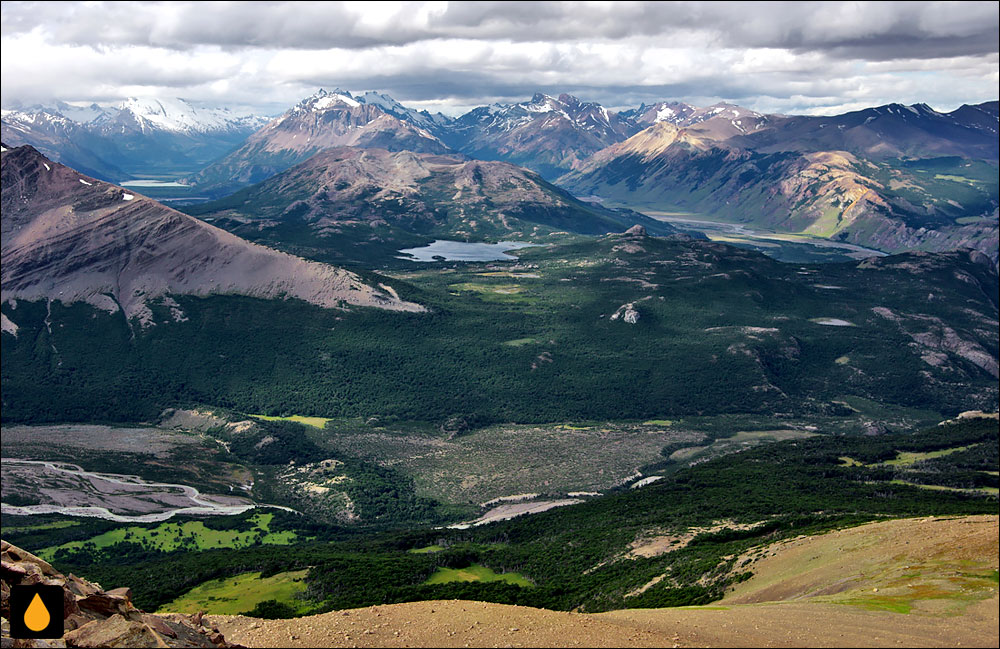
[2,146,420,320]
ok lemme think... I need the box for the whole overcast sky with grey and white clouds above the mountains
[0,0,1000,114]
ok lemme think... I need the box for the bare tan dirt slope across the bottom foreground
[211,516,1000,647]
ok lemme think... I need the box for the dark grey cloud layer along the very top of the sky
[3,2,1000,60]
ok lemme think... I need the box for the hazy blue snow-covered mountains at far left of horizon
[0,98,267,182]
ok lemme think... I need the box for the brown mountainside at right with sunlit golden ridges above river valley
[559,105,998,261]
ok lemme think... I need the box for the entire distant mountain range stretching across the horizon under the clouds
[4,89,1000,261]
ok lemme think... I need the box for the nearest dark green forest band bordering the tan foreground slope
[5,419,1000,616]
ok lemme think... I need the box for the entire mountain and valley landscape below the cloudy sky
[0,89,1000,646]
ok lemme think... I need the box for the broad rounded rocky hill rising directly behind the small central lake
[188,147,677,261]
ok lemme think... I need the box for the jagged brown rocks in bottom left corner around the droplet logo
[0,541,240,647]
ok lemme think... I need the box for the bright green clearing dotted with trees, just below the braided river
[37,514,296,561]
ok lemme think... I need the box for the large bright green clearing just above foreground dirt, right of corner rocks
[158,570,310,615]
